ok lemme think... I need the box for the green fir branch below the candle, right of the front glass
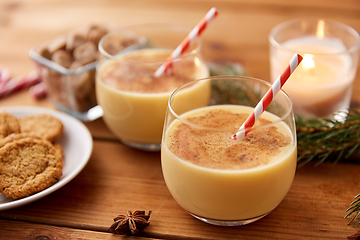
[295,109,360,167]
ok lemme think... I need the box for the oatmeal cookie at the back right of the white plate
[19,114,63,142]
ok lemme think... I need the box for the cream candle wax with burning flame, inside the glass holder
[271,21,357,118]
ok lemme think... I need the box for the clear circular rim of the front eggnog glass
[167,76,293,132]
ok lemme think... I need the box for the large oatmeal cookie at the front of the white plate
[0,138,63,199]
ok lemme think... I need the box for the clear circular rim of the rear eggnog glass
[98,23,202,64]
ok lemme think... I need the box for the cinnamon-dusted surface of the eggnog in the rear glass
[101,50,199,93]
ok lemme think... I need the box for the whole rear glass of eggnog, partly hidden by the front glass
[96,24,209,151]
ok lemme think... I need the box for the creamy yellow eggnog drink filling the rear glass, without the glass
[96,48,210,150]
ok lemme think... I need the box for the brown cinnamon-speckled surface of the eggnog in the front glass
[169,109,291,169]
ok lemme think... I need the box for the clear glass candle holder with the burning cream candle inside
[269,19,360,120]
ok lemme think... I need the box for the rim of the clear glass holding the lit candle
[268,17,360,57]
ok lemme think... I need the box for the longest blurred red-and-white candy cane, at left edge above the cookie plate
[0,70,41,98]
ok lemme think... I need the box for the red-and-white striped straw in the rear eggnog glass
[155,7,219,77]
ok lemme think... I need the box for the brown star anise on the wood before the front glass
[108,210,151,235]
